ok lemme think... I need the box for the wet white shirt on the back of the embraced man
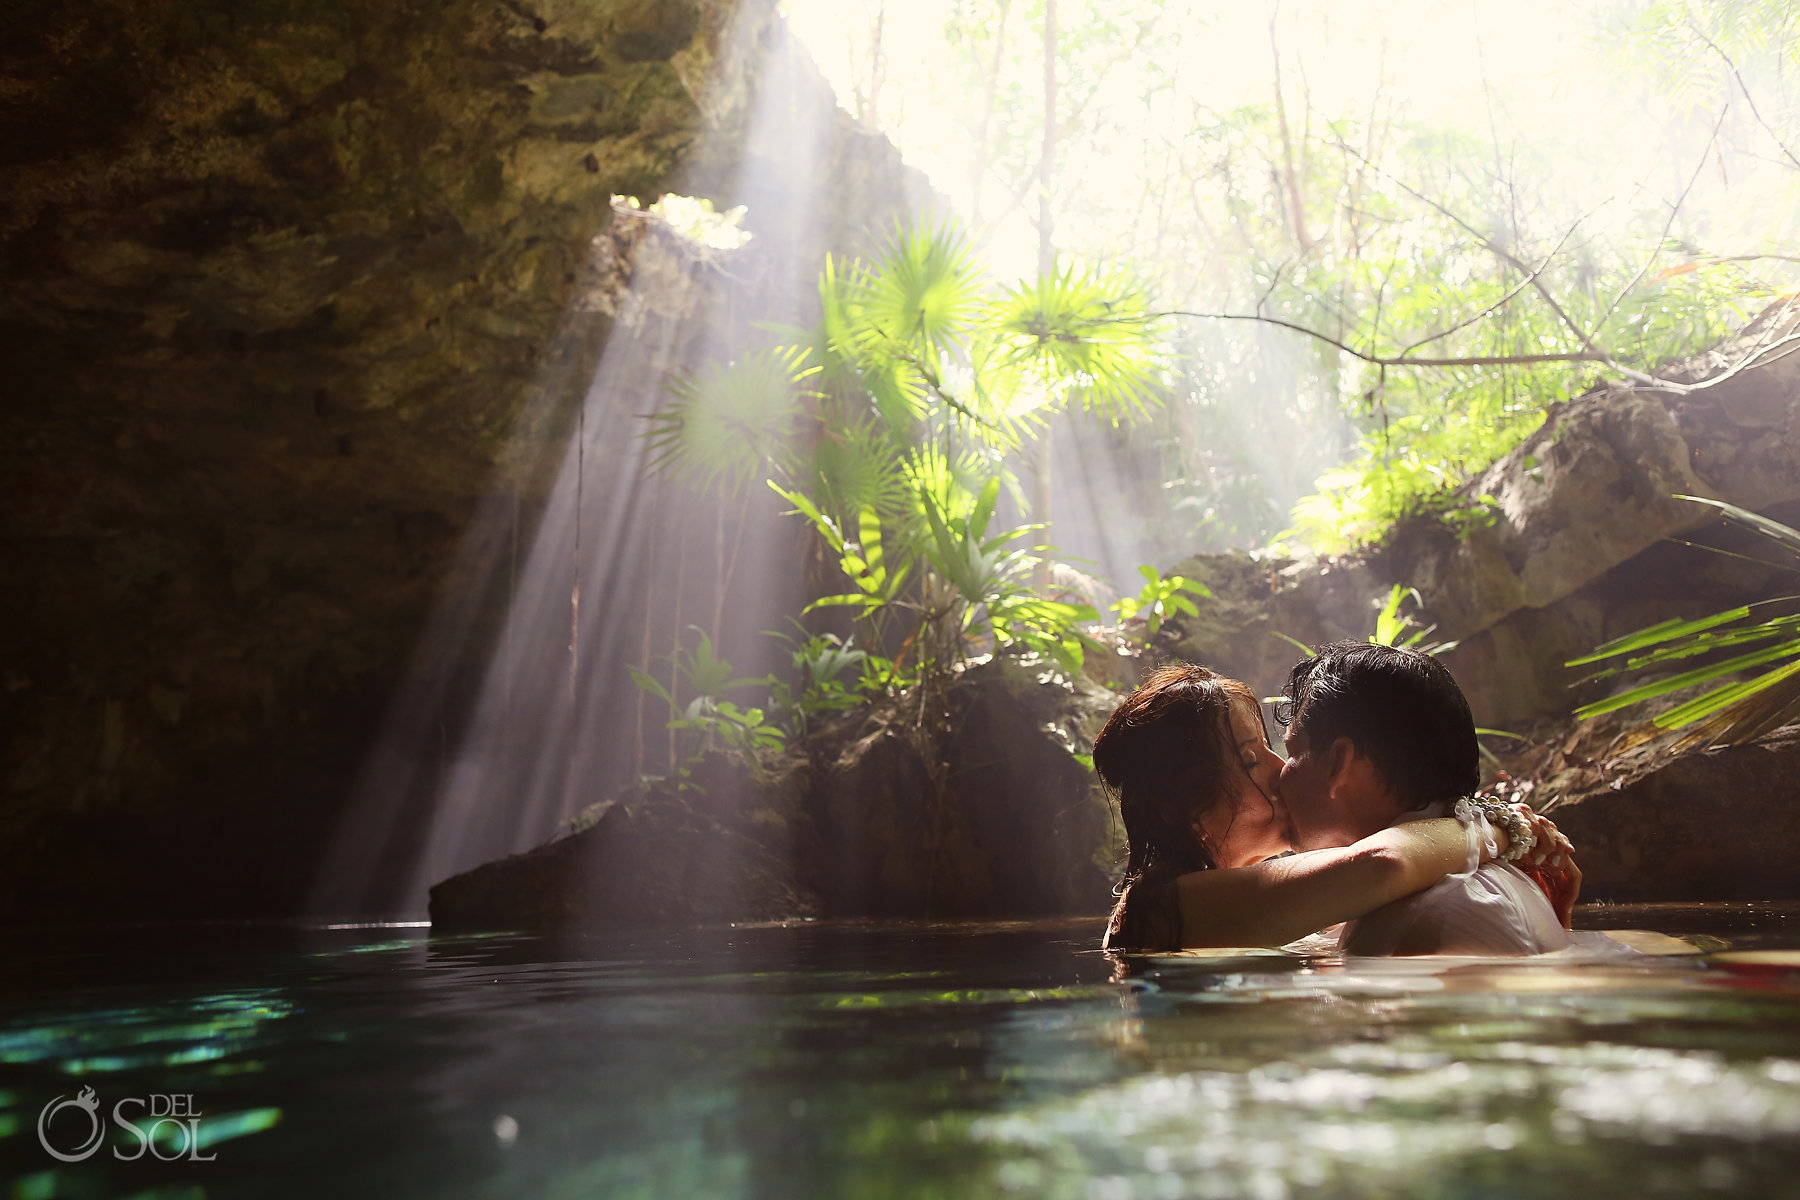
[1337,804,1573,955]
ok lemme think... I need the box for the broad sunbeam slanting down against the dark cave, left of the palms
[311,9,885,914]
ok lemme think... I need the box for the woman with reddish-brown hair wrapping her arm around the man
[1094,664,1568,950]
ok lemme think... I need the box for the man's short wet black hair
[1274,642,1481,808]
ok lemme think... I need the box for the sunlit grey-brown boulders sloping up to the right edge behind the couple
[1163,306,1800,729]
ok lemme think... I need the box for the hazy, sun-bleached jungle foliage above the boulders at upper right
[866,0,1800,558]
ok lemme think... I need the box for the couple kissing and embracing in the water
[1094,642,1580,955]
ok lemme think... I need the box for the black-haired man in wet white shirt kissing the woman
[1276,642,1580,954]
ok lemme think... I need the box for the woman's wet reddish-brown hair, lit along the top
[1094,664,1260,891]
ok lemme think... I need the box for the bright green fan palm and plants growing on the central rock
[634,223,1166,748]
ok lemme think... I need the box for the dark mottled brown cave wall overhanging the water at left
[0,0,918,919]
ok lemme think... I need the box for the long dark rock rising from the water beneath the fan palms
[430,658,1116,928]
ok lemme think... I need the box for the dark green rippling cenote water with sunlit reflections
[0,905,1800,1200]
